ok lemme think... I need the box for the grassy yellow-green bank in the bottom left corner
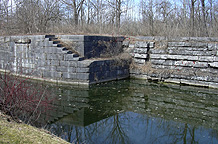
[0,111,68,144]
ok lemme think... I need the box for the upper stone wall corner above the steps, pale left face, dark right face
[57,35,124,59]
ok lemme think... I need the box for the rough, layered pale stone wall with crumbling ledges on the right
[129,37,218,88]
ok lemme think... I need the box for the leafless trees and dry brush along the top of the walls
[0,0,218,37]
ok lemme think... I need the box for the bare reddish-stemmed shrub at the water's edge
[0,71,52,123]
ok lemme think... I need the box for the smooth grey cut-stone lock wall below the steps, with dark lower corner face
[0,35,129,84]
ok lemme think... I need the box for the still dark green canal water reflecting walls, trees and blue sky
[33,79,218,144]
